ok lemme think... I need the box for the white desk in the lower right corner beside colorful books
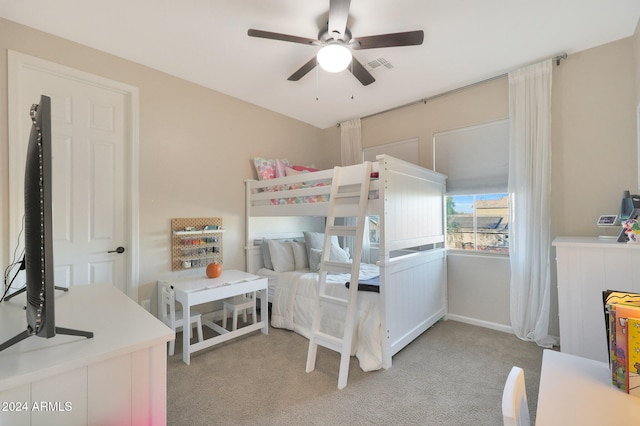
[540,349,640,426]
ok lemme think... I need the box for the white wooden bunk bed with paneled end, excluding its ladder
[245,155,447,371]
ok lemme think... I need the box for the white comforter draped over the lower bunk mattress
[271,264,383,371]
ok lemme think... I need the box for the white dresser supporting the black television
[0,284,174,425]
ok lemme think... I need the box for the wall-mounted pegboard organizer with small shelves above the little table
[171,217,224,271]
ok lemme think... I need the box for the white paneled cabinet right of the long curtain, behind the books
[553,237,640,362]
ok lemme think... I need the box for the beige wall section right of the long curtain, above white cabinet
[552,38,638,235]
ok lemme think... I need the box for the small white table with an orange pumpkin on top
[163,270,269,365]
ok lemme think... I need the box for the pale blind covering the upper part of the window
[433,119,509,195]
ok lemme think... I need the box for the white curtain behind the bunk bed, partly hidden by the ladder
[340,118,371,262]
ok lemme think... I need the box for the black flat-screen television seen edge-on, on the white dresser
[0,95,93,351]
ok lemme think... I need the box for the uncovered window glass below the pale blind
[446,193,509,254]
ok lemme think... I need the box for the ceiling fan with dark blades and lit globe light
[247,0,424,86]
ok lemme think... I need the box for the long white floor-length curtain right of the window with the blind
[509,60,556,347]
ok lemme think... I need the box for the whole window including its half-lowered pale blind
[433,120,509,254]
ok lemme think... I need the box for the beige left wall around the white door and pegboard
[0,19,336,299]
